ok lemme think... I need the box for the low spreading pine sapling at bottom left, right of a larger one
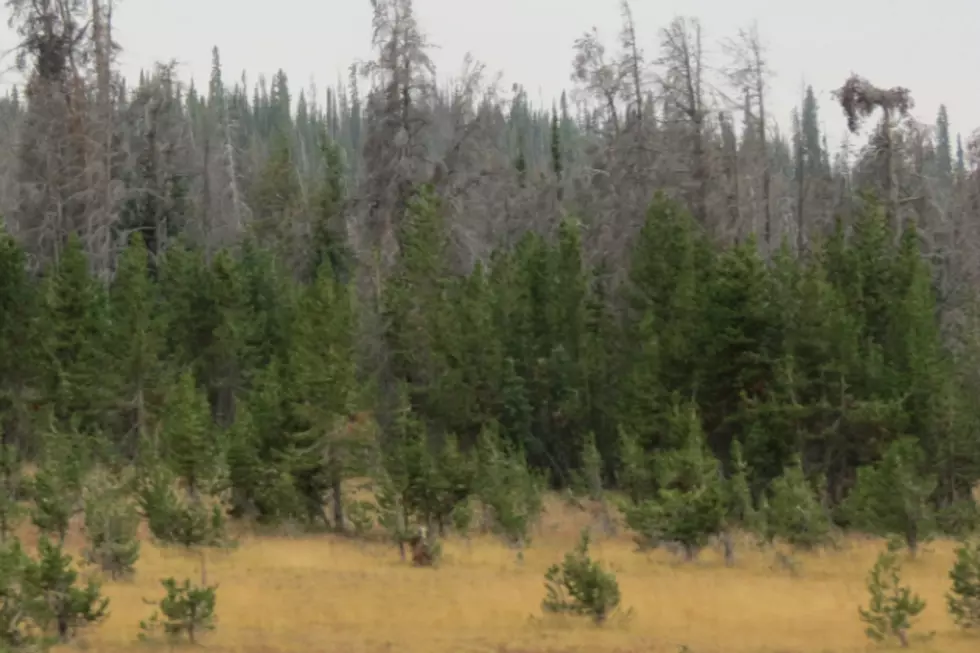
[140,577,218,644]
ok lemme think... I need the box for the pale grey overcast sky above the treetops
[3,0,980,150]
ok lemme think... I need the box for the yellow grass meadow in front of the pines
[44,494,980,653]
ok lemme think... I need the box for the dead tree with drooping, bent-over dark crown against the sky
[834,75,913,233]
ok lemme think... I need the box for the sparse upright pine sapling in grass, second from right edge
[858,542,926,648]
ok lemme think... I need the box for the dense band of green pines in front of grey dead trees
[0,182,980,526]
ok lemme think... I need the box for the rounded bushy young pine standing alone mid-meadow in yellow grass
[541,529,620,624]
